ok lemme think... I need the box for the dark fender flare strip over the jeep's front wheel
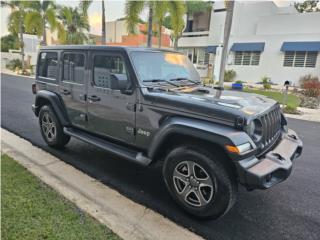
[148,117,256,159]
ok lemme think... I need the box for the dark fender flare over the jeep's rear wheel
[34,90,70,126]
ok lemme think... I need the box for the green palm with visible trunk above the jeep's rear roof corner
[25,0,57,45]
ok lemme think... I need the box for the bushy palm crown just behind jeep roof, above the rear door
[57,5,90,44]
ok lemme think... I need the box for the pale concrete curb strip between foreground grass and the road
[1,129,202,240]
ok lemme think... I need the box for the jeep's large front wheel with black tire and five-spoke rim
[163,146,238,219]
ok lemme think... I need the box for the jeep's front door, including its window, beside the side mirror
[88,52,136,143]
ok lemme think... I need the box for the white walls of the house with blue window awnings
[179,1,320,84]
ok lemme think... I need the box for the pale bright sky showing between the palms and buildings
[0,0,301,36]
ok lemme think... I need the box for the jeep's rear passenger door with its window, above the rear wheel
[60,52,87,128]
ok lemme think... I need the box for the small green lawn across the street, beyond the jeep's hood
[244,88,300,108]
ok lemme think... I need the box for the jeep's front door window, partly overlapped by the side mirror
[93,55,129,90]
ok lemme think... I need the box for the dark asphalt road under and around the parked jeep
[1,74,320,240]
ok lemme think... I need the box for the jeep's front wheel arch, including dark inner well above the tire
[148,117,254,161]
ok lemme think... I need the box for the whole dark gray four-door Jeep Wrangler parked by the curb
[32,46,302,218]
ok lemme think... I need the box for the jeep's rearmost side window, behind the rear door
[38,52,58,80]
